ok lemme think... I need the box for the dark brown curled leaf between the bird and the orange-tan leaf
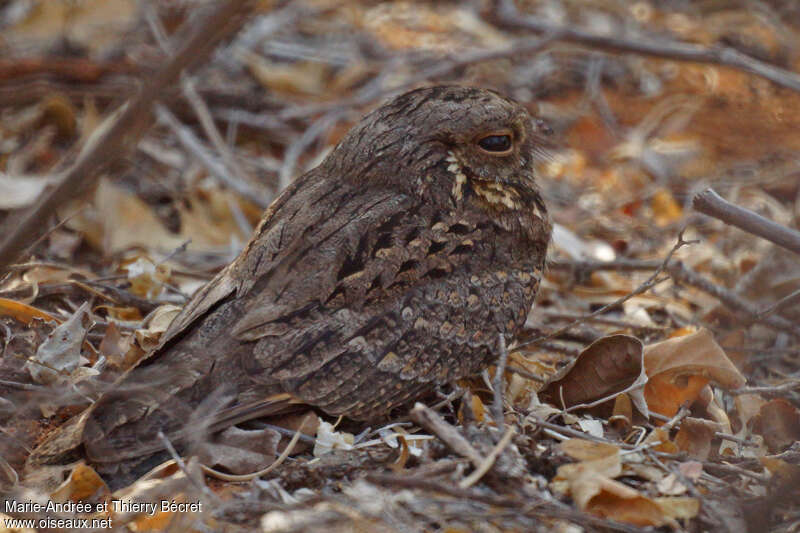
[541,335,647,412]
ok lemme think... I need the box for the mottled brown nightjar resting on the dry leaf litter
[83,87,551,470]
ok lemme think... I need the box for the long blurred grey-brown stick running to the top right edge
[498,0,800,91]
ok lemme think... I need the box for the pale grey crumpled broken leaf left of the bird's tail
[25,302,89,384]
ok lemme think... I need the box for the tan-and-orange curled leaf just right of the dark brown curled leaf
[644,329,746,416]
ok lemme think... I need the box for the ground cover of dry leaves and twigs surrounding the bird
[0,0,800,531]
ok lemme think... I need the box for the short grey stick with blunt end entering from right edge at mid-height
[692,189,800,255]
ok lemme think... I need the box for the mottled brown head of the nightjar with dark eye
[328,86,552,237]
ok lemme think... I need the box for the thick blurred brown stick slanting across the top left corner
[0,0,258,271]
